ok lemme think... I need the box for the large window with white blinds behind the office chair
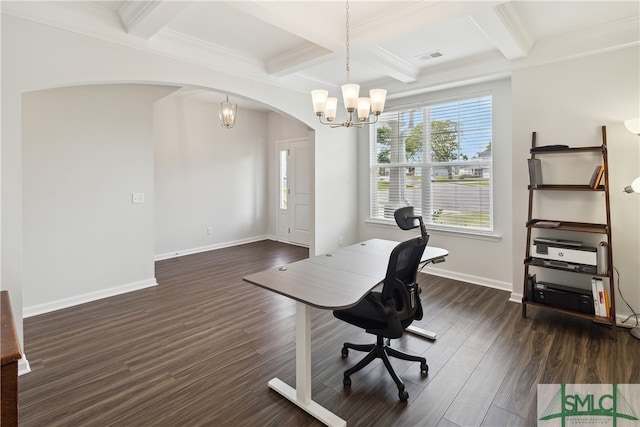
[370,94,493,232]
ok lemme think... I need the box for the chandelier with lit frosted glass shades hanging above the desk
[311,0,387,128]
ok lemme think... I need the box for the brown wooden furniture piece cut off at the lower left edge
[0,291,22,427]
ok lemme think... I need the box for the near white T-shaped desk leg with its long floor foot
[269,301,347,427]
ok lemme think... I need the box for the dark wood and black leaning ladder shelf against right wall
[522,126,617,341]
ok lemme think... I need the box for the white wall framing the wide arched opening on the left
[0,14,357,368]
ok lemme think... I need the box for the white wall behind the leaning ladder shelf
[512,46,640,317]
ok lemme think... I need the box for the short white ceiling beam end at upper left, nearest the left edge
[118,0,192,40]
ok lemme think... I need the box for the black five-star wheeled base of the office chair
[342,336,429,402]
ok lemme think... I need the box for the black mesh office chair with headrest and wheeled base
[333,207,429,402]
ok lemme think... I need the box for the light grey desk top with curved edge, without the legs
[243,239,449,310]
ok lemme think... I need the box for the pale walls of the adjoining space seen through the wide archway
[22,85,312,316]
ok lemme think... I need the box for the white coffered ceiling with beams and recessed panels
[2,0,640,110]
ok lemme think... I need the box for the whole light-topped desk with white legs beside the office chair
[243,239,449,426]
